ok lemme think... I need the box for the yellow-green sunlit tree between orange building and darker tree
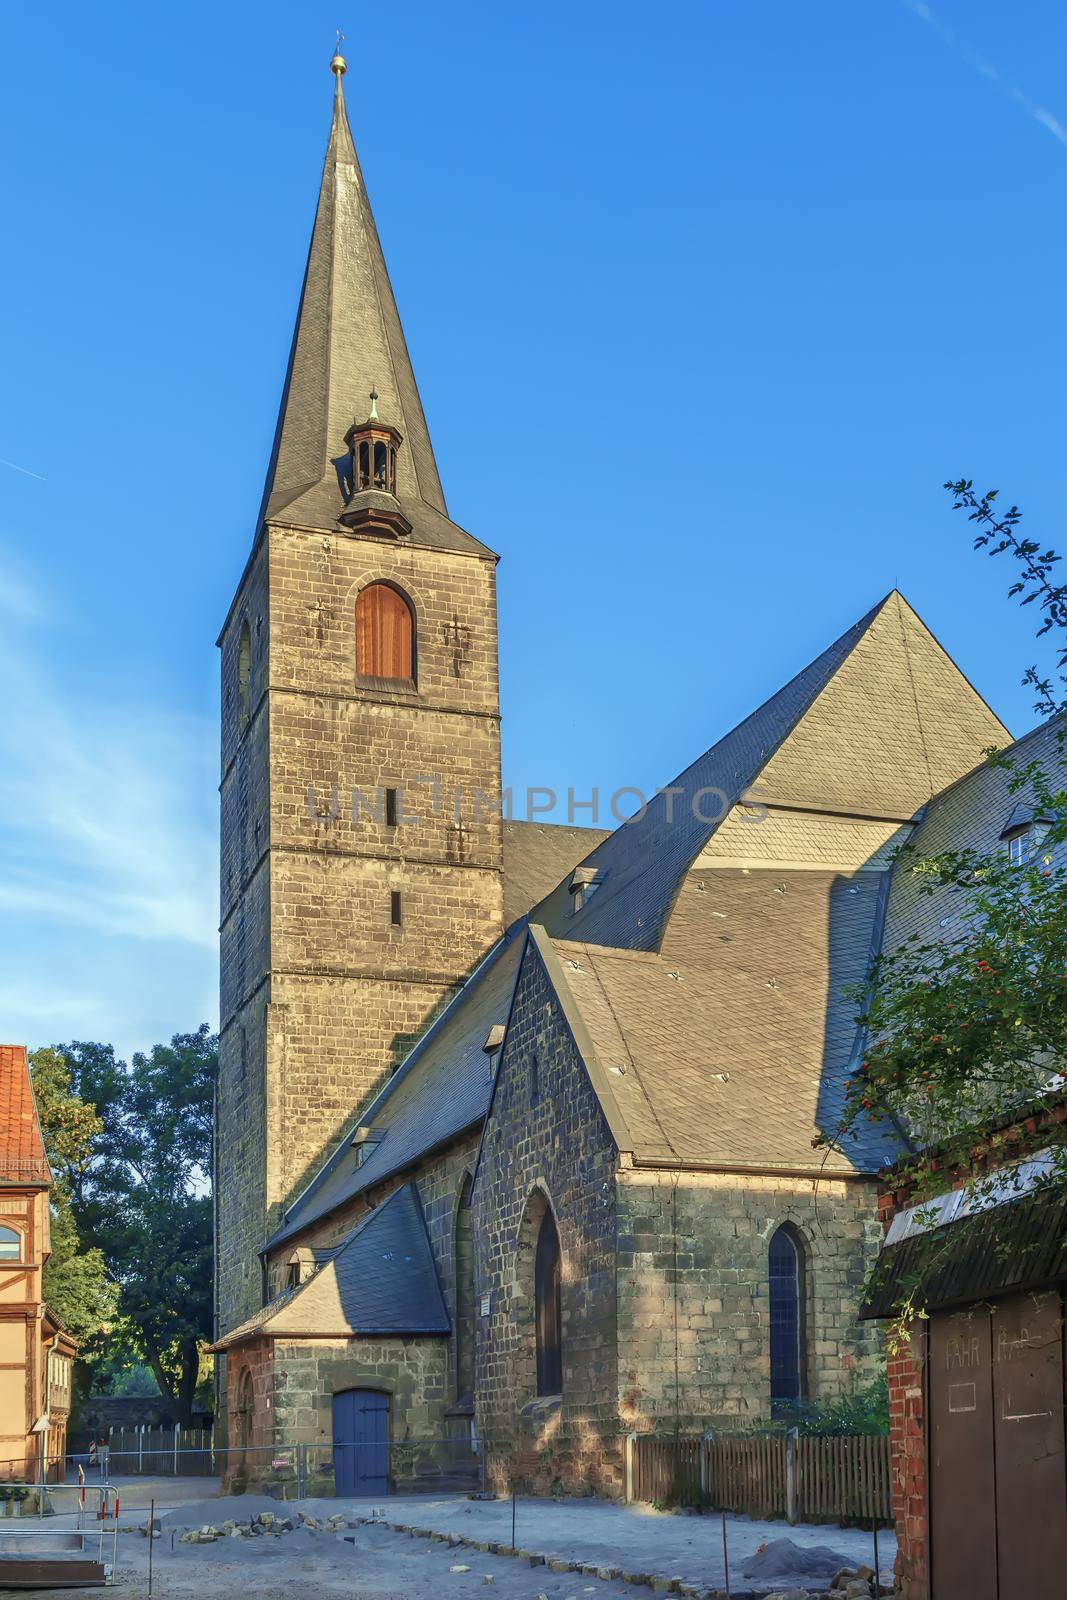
[29,1050,118,1360]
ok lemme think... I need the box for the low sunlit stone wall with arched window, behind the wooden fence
[617,1168,881,1432]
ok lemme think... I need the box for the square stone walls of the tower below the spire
[216,525,502,1333]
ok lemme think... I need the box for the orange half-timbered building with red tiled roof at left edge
[0,1045,77,1482]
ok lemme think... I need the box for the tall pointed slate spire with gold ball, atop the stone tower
[259,50,451,542]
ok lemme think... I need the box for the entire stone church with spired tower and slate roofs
[214,56,1009,1494]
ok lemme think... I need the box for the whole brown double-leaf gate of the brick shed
[929,1290,1067,1600]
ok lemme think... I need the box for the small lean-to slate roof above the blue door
[211,1184,451,1350]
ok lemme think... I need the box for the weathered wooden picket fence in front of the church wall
[627,1434,893,1523]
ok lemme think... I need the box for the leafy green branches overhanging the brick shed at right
[822,480,1067,1198]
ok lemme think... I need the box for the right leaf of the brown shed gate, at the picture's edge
[992,1291,1067,1600]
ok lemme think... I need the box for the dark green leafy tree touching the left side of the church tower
[52,1022,218,1426]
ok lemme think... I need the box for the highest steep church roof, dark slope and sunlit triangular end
[539,590,1005,950]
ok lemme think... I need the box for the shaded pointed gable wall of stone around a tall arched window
[474,946,622,1493]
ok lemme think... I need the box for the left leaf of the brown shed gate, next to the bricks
[928,1302,1009,1600]
